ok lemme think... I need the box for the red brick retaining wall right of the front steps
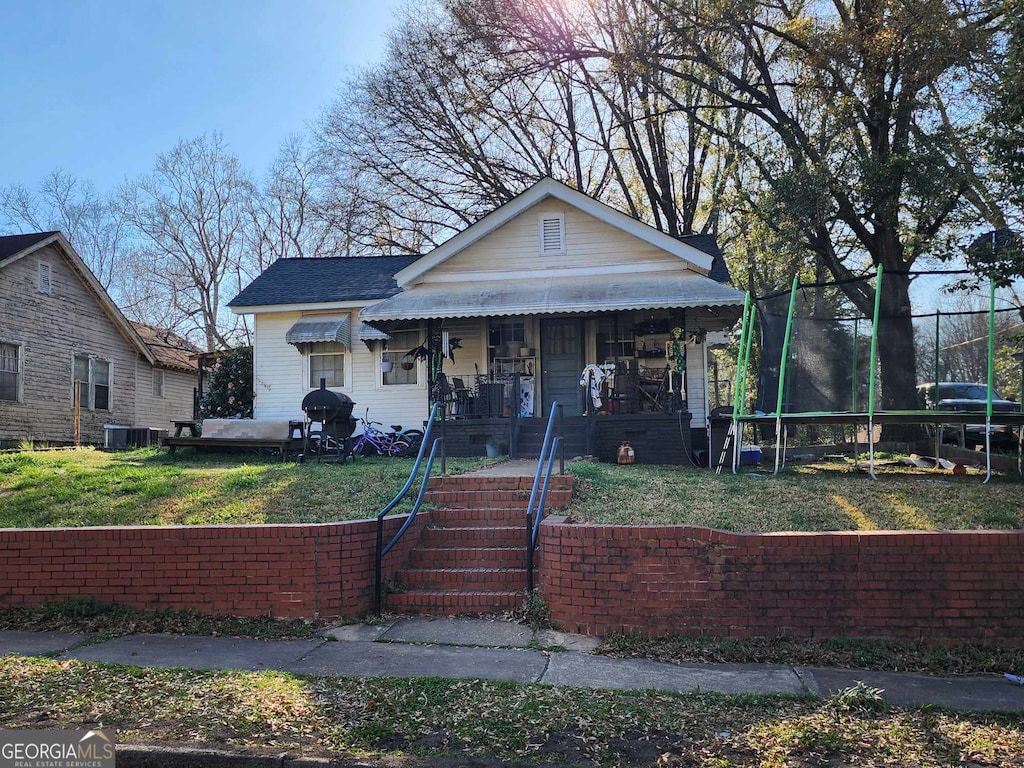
[537,517,1024,645]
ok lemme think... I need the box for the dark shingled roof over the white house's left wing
[227,256,420,311]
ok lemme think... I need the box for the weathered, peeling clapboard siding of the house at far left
[0,247,136,443]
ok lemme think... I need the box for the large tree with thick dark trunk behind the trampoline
[464,0,1004,430]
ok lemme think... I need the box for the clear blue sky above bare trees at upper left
[0,0,399,191]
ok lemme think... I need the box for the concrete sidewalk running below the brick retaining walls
[0,616,1024,712]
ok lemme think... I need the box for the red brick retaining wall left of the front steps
[0,514,429,617]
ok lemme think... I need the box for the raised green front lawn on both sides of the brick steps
[0,450,1024,531]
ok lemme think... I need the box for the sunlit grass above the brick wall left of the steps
[0,449,483,527]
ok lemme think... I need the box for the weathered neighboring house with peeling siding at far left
[0,232,196,444]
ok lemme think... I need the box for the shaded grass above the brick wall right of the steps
[568,462,1024,532]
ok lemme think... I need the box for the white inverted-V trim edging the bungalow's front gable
[394,177,715,287]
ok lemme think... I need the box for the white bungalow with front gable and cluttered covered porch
[228,179,743,463]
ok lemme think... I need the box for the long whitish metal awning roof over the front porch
[359,273,744,322]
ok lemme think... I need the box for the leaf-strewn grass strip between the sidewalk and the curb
[0,656,1024,767]
